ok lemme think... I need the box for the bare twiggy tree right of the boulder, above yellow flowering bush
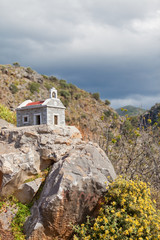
[101,109,160,207]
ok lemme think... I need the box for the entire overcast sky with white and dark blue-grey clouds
[0,0,160,108]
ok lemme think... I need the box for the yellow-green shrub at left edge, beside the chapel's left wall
[0,104,16,125]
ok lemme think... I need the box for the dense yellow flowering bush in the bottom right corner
[74,177,160,240]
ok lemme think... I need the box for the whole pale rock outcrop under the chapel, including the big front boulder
[0,125,116,240]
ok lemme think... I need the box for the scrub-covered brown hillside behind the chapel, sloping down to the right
[0,65,160,195]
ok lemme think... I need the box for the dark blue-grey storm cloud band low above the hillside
[46,56,160,99]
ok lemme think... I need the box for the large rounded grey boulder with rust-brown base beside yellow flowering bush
[25,142,115,240]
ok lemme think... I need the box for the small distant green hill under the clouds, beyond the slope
[116,105,146,116]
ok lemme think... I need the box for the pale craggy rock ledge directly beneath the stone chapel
[0,125,81,202]
